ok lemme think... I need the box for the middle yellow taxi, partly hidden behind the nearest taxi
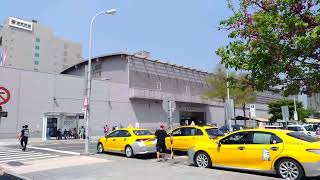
[166,125,224,151]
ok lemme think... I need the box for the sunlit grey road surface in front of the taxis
[0,141,318,180]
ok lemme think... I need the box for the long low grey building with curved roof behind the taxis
[0,53,284,139]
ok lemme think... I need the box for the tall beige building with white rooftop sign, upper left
[0,17,82,73]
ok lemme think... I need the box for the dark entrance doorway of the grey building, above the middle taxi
[180,111,207,125]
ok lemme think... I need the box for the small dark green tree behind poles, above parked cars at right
[268,100,311,122]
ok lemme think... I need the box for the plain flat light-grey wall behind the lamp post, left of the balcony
[0,67,134,138]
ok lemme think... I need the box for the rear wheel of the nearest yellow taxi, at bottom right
[276,159,305,180]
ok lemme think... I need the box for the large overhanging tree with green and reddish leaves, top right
[216,0,320,95]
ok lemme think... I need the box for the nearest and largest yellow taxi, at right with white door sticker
[188,129,320,180]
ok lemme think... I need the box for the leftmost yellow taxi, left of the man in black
[97,128,156,158]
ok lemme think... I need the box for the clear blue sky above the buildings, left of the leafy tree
[0,0,231,71]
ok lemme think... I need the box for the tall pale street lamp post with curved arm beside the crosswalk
[84,9,117,154]
